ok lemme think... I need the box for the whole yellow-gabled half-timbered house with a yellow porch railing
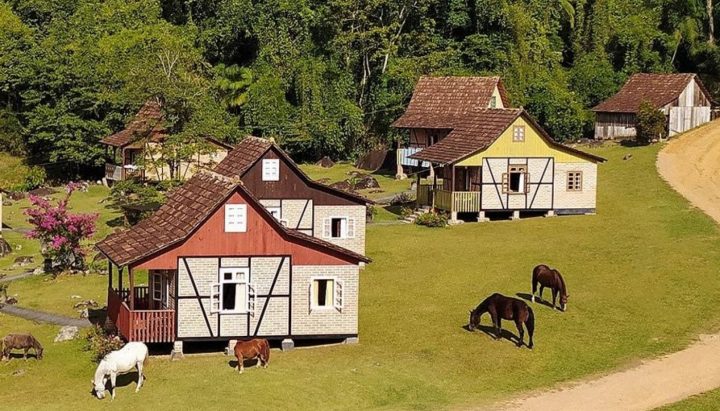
[396,108,605,221]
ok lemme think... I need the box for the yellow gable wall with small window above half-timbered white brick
[457,117,590,166]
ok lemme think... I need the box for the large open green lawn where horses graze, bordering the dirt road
[0,146,720,409]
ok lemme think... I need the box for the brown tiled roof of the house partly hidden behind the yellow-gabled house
[393,77,510,129]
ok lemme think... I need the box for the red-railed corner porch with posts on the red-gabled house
[107,266,175,343]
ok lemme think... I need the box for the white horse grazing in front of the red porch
[92,342,148,399]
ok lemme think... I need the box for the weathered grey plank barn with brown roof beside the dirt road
[592,73,712,139]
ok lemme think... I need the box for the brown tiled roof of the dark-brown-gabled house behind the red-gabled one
[214,136,372,204]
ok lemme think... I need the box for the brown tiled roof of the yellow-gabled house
[410,108,605,164]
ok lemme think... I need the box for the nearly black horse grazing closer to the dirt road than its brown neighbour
[468,293,535,349]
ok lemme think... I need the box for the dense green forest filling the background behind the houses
[0,0,720,177]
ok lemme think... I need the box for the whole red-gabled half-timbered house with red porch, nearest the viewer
[97,171,369,354]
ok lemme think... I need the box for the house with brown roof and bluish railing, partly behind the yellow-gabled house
[392,76,510,176]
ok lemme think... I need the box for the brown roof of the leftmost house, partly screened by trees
[100,100,167,147]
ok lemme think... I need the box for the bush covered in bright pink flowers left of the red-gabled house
[25,183,98,270]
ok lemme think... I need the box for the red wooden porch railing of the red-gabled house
[108,287,175,343]
